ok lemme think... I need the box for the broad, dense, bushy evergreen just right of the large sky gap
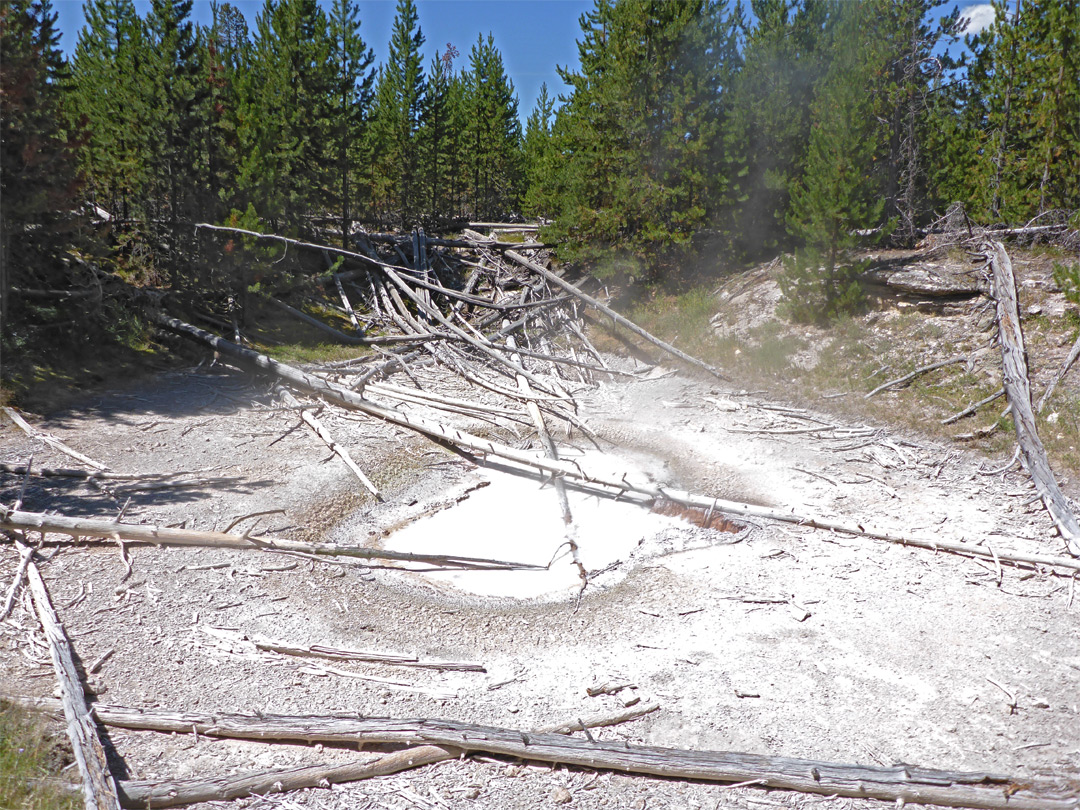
[544,0,732,278]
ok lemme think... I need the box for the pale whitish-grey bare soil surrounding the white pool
[0,336,1080,808]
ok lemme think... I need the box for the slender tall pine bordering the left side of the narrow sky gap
[329,0,375,247]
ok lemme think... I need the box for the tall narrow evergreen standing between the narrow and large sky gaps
[370,0,424,226]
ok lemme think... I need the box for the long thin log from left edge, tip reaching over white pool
[0,505,543,570]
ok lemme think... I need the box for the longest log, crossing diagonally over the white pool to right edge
[150,313,1080,570]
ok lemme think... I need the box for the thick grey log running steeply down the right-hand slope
[986,242,1080,557]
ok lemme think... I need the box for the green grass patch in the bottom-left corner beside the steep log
[0,703,83,810]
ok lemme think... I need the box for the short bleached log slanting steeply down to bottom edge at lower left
[26,561,120,810]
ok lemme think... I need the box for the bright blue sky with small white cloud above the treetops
[54,0,993,121]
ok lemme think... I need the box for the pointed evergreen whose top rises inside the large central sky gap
[465,33,522,219]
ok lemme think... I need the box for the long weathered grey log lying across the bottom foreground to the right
[8,705,1080,810]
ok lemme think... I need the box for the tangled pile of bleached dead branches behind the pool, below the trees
[184,225,720,444]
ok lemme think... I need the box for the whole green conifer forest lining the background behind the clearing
[0,0,1080,348]
